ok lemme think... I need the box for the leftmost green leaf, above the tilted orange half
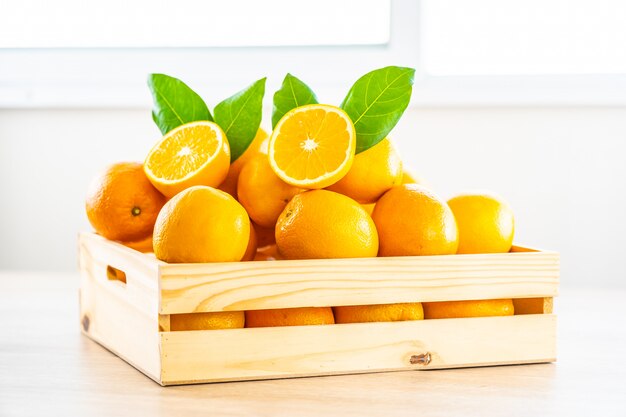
[148,74,213,134]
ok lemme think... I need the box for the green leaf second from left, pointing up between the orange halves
[213,78,266,163]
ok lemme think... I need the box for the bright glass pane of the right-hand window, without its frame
[422,0,626,76]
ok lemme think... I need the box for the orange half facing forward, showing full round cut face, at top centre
[269,104,356,189]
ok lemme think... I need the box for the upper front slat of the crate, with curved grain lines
[160,248,559,314]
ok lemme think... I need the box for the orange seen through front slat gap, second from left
[246,307,335,327]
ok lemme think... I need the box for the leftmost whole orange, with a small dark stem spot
[85,162,166,242]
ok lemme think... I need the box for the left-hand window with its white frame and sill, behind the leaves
[0,0,410,107]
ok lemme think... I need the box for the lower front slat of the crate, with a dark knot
[161,315,556,385]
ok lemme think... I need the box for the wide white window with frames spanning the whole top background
[0,0,626,107]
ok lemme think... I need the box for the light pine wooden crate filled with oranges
[79,233,559,385]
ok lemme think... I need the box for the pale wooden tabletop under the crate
[0,272,626,417]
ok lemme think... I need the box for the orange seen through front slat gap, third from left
[333,303,424,323]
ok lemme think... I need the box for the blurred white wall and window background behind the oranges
[0,0,626,287]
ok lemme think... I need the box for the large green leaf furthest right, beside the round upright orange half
[341,67,415,153]
